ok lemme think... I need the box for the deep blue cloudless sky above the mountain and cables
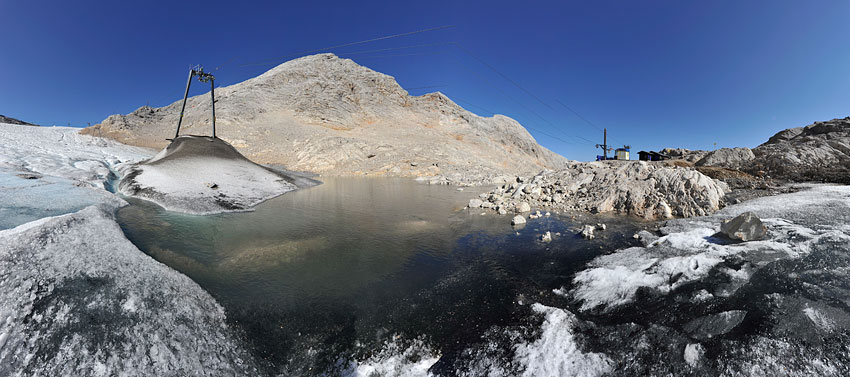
[0,0,850,160]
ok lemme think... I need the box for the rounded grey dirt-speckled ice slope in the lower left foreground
[0,206,258,376]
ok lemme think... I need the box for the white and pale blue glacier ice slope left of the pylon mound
[0,123,151,229]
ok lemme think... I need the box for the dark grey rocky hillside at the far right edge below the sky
[746,117,850,183]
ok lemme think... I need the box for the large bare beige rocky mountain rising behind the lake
[83,54,566,183]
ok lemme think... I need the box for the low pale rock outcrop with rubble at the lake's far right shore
[470,161,728,219]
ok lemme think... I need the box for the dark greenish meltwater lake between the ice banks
[118,178,647,375]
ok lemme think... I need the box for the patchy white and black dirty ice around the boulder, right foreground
[554,185,850,376]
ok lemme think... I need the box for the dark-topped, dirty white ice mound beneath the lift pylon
[118,136,314,214]
